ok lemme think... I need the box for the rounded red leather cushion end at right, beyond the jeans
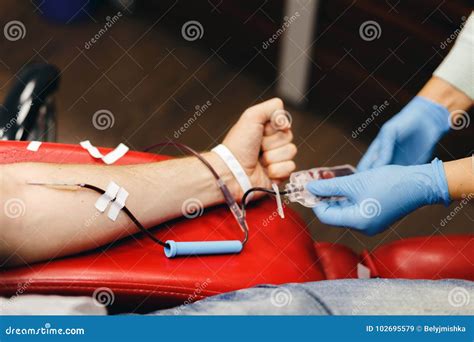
[362,235,474,280]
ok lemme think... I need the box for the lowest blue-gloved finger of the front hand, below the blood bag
[313,202,356,227]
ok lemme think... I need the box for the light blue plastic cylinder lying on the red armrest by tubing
[165,240,242,258]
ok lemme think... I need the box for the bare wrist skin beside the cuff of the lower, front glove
[444,156,474,200]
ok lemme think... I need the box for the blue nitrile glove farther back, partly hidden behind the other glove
[357,96,450,171]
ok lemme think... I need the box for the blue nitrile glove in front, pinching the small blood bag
[307,159,451,235]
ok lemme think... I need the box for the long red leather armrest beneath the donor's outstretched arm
[0,142,324,310]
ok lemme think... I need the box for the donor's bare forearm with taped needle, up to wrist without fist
[0,152,237,265]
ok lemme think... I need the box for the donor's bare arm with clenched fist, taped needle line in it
[0,99,296,267]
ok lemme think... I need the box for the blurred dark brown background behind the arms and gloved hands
[0,0,474,251]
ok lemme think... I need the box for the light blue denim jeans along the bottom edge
[154,279,474,315]
